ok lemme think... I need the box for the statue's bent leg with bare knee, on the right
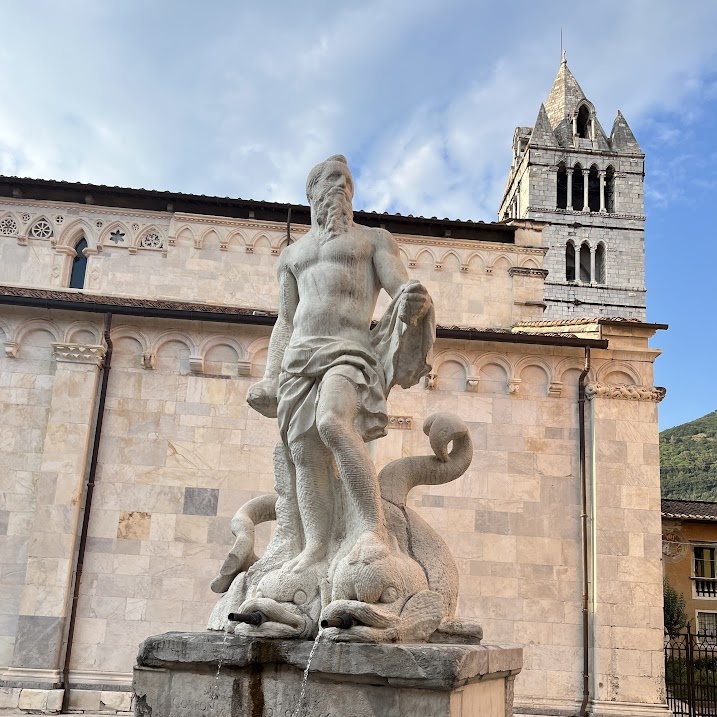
[316,373,386,542]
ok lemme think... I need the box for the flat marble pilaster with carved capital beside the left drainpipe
[3,343,105,690]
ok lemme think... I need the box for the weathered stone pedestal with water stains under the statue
[134,632,523,717]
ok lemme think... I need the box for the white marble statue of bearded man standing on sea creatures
[209,155,480,642]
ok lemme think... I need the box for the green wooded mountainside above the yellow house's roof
[660,411,717,501]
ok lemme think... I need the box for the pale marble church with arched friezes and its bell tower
[0,64,667,715]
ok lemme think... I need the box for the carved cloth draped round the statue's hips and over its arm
[278,282,435,445]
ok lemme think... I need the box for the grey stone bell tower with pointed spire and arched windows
[498,53,646,321]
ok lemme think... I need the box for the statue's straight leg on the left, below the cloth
[287,429,334,572]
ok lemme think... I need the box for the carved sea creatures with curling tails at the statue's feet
[208,413,482,643]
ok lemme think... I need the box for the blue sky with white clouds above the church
[0,0,717,429]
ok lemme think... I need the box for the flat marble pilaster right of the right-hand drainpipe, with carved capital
[586,383,669,717]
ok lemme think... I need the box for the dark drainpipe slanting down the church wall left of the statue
[62,313,112,712]
